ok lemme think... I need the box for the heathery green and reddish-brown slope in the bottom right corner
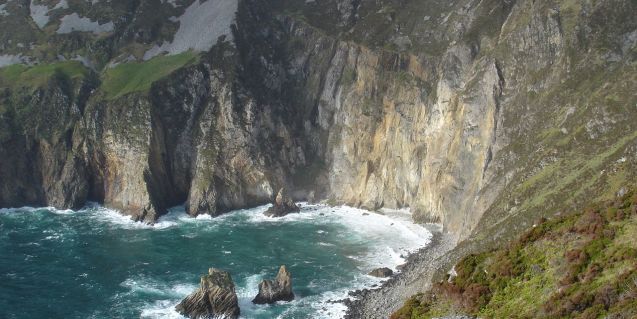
[391,190,637,319]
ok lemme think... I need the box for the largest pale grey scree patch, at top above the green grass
[144,0,238,60]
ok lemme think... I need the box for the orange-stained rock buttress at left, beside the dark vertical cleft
[86,96,163,222]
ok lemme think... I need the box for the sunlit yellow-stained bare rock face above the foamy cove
[314,44,503,239]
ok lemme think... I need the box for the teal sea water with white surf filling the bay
[0,206,430,318]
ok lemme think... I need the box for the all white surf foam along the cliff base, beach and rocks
[0,203,432,319]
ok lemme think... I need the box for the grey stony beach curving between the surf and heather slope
[344,230,455,319]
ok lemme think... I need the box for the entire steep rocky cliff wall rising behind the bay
[0,0,637,240]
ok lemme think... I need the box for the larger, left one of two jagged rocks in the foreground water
[175,268,239,319]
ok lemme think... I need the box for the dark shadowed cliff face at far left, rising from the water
[0,76,92,211]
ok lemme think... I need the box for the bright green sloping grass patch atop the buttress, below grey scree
[102,51,198,99]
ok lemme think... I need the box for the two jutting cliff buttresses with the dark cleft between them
[79,56,284,222]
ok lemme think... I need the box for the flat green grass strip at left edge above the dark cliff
[0,61,88,88]
